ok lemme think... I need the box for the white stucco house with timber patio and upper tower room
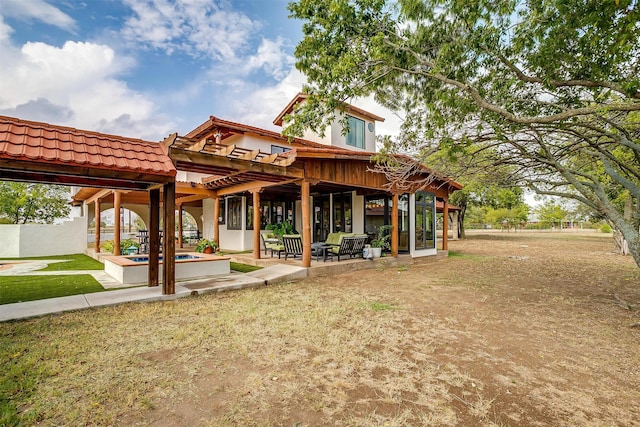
[74,94,461,264]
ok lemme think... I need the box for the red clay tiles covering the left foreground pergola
[0,116,176,177]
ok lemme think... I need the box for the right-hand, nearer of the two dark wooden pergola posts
[162,182,176,295]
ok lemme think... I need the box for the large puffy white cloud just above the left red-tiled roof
[0,39,171,140]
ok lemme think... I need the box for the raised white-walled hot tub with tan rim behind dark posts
[103,252,231,285]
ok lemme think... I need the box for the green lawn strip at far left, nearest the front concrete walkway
[0,274,105,304]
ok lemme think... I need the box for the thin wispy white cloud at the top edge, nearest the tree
[122,0,260,61]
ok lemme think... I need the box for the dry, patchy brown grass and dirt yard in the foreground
[0,232,640,426]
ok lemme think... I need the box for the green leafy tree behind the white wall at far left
[0,181,71,224]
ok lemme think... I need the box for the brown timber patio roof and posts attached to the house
[164,129,461,267]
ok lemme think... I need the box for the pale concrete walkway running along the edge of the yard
[0,264,307,322]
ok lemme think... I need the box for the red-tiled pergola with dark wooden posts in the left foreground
[0,116,176,294]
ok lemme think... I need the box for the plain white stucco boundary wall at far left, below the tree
[0,216,87,258]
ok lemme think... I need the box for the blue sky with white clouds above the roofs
[0,0,397,141]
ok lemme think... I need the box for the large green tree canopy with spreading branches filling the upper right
[286,0,640,266]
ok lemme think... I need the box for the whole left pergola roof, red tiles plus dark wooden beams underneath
[0,116,176,188]
